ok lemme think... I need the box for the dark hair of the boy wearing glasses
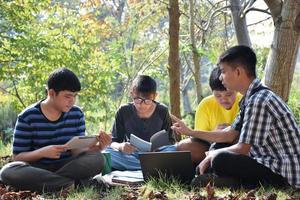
[132,75,156,95]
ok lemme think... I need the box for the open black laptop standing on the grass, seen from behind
[139,151,195,184]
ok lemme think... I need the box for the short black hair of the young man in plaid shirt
[219,45,257,78]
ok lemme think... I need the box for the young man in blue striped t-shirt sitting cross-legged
[0,68,111,192]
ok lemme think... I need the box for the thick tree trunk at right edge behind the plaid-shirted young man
[264,0,300,101]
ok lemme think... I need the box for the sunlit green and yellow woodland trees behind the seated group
[0,0,299,136]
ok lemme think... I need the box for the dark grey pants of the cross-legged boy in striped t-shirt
[0,152,104,192]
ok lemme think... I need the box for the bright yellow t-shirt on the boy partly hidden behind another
[195,93,242,131]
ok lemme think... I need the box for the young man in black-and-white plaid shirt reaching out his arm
[173,46,300,188]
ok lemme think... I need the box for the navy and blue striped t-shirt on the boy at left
[13,102,85,163]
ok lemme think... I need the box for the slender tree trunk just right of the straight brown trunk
[189,0,202,103]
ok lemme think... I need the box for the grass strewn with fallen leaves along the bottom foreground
[67,181,300,200]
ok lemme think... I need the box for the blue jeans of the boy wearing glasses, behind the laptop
[104,145,177,171]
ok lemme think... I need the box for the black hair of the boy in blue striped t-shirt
[47,67,81,93]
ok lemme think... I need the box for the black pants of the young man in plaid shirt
[211,152,288,188]
